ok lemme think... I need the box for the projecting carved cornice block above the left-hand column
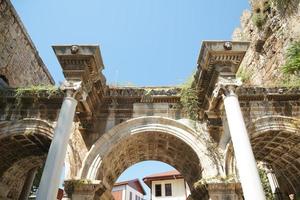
[53,45,107,113]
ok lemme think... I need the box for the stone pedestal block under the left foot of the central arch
[64,180,105,200]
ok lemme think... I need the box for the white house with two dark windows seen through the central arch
[143,170,191,200]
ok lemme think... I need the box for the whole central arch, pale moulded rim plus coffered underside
[80,116,223,199]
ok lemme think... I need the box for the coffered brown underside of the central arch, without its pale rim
[96,132,202,189]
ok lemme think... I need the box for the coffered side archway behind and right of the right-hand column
[225,116,300,193]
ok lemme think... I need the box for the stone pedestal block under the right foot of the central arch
[207,183,243,200]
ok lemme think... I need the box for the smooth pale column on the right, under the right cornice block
[223,86,266,200]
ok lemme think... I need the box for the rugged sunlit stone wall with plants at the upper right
[233,0,300,86]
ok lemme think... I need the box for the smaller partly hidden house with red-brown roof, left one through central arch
[112,179,146,200]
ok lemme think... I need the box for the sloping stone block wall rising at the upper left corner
[0,0,54,87]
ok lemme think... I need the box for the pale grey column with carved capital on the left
[37,83,81,200]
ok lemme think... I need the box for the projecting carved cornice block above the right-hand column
[193,41,249,114]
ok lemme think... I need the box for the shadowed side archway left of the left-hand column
[0,119,53,199]
